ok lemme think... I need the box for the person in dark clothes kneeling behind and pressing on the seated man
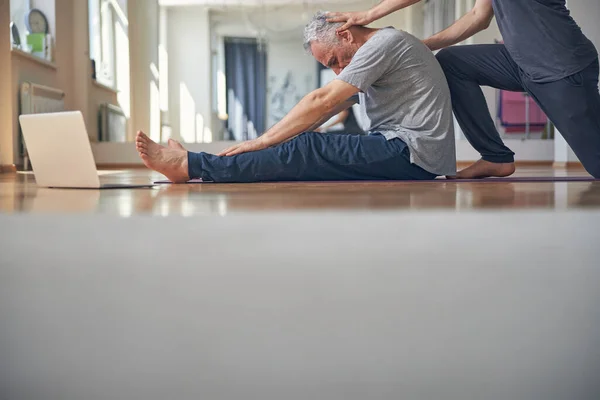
[328,0,600,178]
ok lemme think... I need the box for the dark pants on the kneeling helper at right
[437,44,600,178]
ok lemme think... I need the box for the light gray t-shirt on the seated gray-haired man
[337,27,456,175]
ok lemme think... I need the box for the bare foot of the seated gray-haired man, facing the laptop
[135,131,190,183]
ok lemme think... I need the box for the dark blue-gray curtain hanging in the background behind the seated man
[225,38,267,140]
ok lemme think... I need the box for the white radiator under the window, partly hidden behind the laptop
[19,82,65,169]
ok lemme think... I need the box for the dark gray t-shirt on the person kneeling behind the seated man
[493,0,598,83]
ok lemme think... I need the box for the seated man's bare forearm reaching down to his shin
[219,79,359,156]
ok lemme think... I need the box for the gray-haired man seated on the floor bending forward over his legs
[136,13,456,182]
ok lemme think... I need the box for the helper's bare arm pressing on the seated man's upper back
[423,0,494,51]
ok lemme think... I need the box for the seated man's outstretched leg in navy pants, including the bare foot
[137,132,435,182]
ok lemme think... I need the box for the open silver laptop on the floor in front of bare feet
[19,111,153,189]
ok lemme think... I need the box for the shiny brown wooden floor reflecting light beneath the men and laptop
[0,167,600,216]
